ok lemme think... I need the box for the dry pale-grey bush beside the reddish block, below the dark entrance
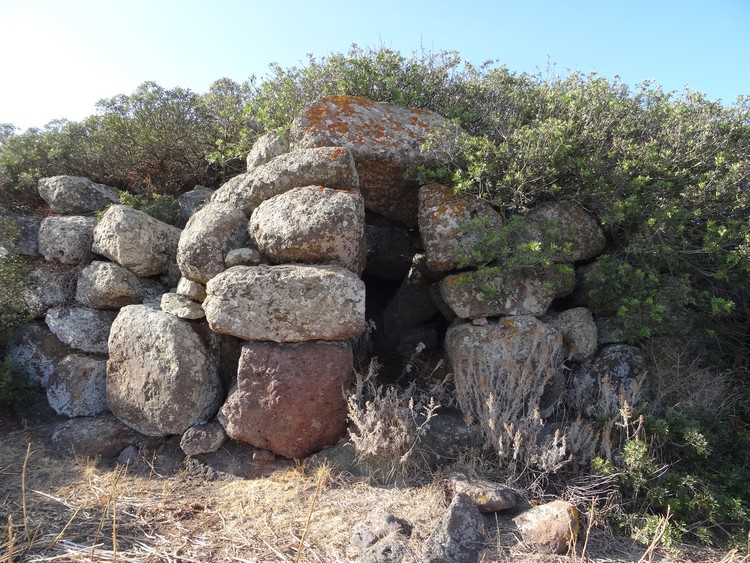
[347,359,439,481]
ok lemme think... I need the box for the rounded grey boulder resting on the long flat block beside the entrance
[250,186,365,275]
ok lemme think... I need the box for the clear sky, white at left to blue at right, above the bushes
[0,0,750,128]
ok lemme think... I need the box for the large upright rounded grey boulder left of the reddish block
[107,305,222,436]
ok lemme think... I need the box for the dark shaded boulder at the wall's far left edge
[7,323,70,387]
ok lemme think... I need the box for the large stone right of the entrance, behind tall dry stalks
[445,316,564,426]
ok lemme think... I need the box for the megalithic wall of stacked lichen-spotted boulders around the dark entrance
[6,96,648,468]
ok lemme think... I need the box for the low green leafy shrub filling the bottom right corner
[594,407,750,546]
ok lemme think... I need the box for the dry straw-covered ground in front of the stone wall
[0,394,748,563]
